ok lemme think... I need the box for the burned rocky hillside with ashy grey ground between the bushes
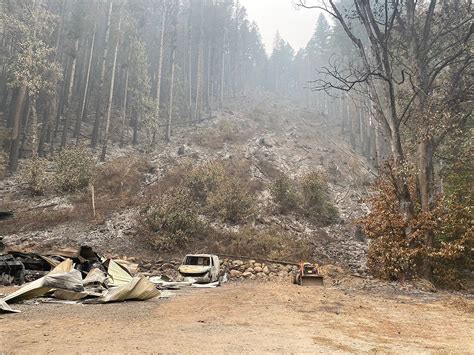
[0,96,374,274]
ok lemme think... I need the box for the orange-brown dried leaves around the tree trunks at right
[358,170,474,284]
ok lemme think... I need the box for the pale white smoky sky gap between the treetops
[240,0,320,54]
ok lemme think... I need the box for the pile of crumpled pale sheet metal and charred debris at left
[0,247,160,312]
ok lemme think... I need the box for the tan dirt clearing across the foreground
[0,282,474,353]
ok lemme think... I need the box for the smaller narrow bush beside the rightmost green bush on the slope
[270,174,302,213]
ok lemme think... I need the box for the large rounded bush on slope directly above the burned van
[142,187,204,251]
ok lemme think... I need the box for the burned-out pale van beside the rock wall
[178,254,220,283]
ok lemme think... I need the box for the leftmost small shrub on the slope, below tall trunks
[18,158,51,196]
